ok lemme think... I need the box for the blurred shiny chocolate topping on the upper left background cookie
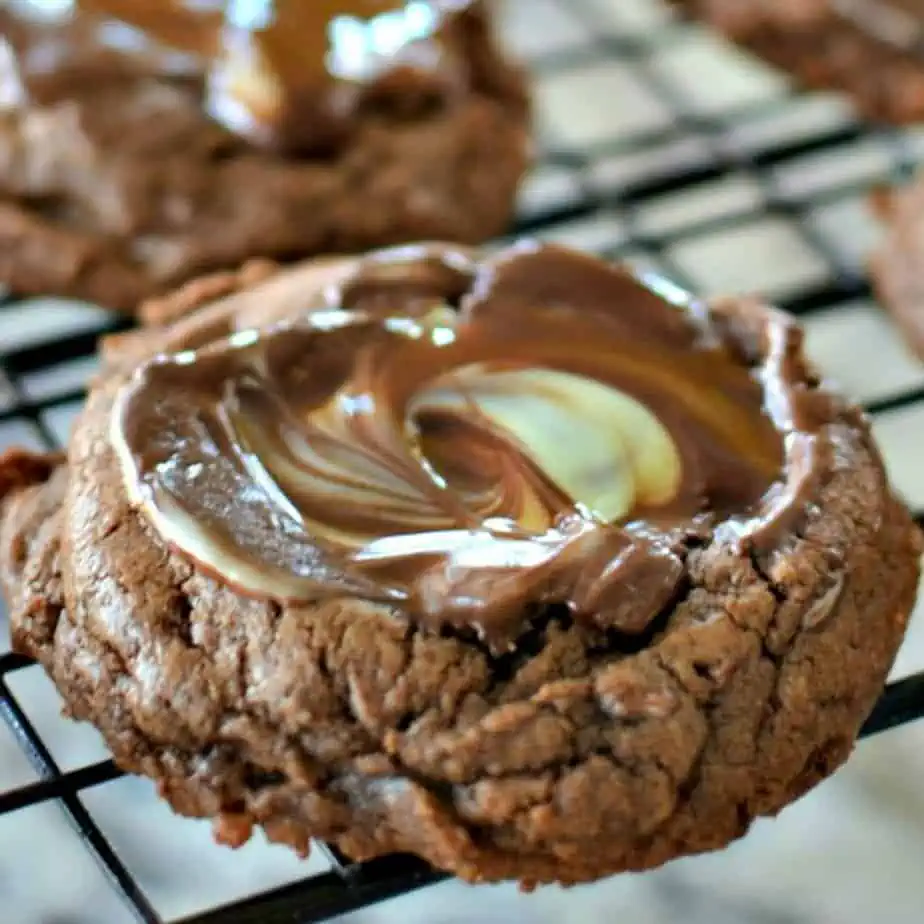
[0,0,472,153]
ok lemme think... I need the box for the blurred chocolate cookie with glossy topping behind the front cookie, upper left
[0,0,530,311]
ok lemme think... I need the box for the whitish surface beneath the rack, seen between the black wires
[0,0,924,924]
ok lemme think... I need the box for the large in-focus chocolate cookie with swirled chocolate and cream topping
[0,244,921,883]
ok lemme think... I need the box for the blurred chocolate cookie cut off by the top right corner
[671,0,924,123]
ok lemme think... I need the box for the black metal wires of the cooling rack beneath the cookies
[0,0,924,924]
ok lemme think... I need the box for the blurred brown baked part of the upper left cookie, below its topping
[0,0,529,310]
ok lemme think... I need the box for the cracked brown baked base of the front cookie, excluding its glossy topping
[0,247,920,884]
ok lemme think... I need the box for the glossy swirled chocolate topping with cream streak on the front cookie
[112,244,800,649]
